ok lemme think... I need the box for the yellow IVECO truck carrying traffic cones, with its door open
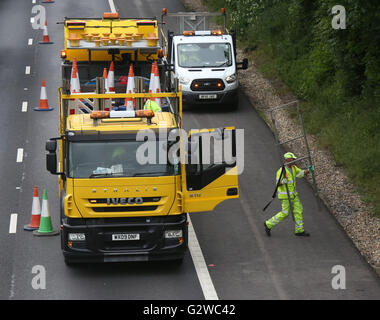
[46,15,239,264]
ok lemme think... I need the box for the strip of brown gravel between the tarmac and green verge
[182,0,380,276]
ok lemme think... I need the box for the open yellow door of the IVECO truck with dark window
[182,127,239,212]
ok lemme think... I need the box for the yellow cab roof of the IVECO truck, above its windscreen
[66,112,177,133]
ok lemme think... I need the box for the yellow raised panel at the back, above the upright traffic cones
[64,19,161,61]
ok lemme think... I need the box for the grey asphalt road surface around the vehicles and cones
[0,0,380,300]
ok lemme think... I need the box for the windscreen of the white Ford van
[178,43,232,68]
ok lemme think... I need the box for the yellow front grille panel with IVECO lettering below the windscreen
[64,176,182,218]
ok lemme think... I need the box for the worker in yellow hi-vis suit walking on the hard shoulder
[264,152,314,237]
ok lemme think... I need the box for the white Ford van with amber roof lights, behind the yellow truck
[163,11,248,108]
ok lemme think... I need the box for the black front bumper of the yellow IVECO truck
[61,214,188,263]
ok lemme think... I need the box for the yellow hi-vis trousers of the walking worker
[266,195,304,233]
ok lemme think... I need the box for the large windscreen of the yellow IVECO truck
[68,141,179,179]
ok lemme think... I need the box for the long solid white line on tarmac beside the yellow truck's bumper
[187,215,219,300]
